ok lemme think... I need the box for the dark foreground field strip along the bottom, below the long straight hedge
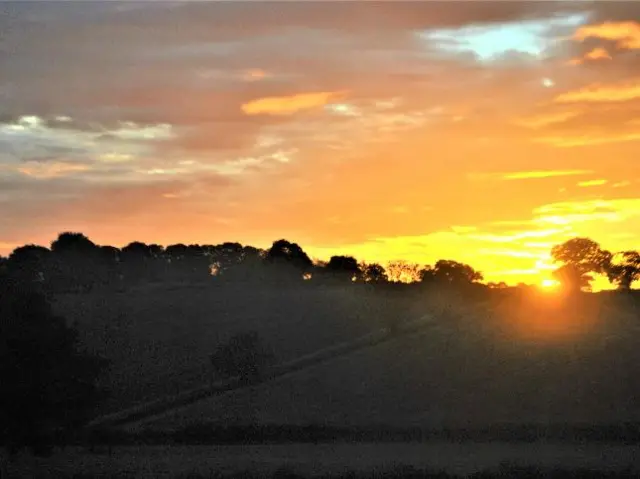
[12,442,640,478]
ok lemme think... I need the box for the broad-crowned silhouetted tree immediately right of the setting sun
[551,238,613,287]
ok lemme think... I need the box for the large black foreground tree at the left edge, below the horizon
[0,275,107,466]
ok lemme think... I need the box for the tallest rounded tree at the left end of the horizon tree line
[51,232,99,291]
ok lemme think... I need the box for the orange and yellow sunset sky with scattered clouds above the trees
[0,0,640,284]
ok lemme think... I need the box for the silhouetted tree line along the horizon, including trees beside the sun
[0,232,640,292]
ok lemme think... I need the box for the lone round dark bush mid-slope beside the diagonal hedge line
[210,332,273,381]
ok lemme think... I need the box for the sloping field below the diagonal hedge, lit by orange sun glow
[135,292,640,429]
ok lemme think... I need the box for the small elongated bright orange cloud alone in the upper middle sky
[242,92,345,115]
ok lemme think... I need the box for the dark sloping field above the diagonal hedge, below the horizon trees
[54,284,440,412]
